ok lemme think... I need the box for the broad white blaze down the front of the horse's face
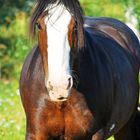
[45,5,71,100]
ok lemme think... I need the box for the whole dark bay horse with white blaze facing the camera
[20,0,140,140]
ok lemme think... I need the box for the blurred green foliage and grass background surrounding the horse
[0,0,140,140]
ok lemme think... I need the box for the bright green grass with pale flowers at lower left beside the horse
[0,80,25,140]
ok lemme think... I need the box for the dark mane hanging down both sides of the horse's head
[30,0,84,48]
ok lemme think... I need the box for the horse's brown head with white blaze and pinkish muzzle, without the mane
[30,0,83,101]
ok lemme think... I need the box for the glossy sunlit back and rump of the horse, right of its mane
[84,17,140,57]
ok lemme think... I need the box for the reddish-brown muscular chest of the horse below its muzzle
[46,89,96,140]
